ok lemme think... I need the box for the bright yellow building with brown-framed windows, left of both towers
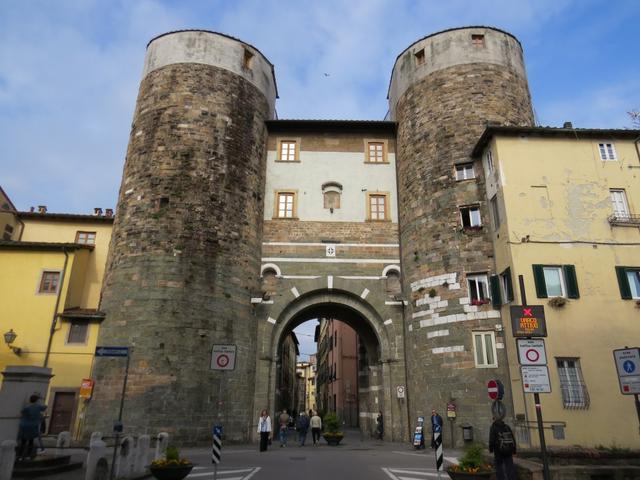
[0,202,113,436]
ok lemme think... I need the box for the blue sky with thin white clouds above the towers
[0,0,640,213]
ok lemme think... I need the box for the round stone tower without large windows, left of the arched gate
[84,30,277,443]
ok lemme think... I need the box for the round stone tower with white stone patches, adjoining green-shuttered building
[388,27,533,445]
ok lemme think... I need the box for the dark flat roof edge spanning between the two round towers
[265,119,397,135]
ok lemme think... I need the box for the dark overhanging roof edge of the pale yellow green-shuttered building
[471,125,640,157]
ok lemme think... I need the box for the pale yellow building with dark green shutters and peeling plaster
[470,124,640,448]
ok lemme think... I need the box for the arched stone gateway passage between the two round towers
[269,291,407,440]
